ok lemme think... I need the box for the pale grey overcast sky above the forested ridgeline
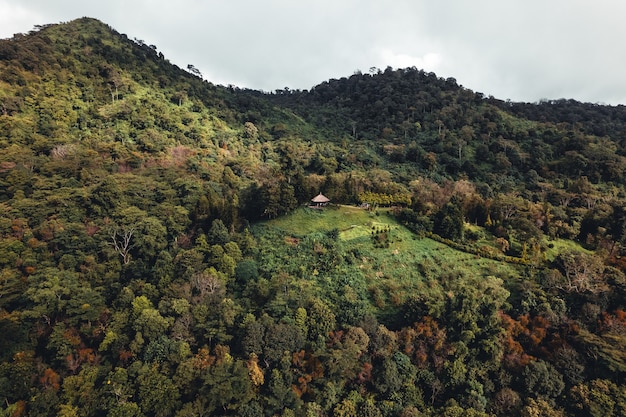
[0,0,626,104]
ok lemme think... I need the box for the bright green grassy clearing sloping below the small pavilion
[260,206,521,310]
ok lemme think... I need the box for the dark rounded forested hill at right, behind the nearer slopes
[271,68,626,182]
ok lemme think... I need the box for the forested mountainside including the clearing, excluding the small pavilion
[0,18,626,417]
